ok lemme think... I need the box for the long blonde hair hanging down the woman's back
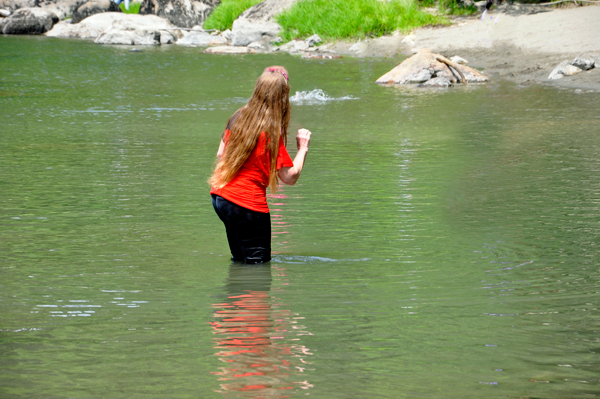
[208,66,291,192]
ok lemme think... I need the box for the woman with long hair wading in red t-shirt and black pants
[209,66,311,263]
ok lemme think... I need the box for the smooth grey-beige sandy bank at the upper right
[332,5,600,91]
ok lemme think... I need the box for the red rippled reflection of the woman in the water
[211,263,312,398]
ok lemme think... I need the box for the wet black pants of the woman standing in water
[211,194,271,263]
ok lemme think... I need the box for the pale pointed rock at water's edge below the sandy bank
[376,51,488,84]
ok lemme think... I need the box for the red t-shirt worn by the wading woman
[210,129,294,213]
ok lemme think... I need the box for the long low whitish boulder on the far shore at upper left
[46,12,183,42]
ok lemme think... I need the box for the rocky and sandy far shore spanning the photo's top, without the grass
[0,0,600,92]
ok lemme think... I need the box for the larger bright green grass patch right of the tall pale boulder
[277,0,450,41]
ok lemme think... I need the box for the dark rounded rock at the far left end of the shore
[2,8,59,35]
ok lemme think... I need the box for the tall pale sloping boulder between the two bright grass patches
[231,0,297,46]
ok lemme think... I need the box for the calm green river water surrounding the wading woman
[0,37,600,399]
